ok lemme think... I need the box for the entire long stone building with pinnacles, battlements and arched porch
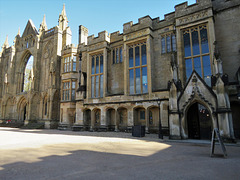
[0,0,240,140]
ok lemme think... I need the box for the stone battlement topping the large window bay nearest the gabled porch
[175,0,212,18]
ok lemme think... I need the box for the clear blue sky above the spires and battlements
[0,0,196,49]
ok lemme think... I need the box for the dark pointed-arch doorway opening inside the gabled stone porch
[187,103,212,139]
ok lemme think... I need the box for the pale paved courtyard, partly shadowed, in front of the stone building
[0,128,240,180]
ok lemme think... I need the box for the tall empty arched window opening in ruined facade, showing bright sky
[23,55,33,92]
